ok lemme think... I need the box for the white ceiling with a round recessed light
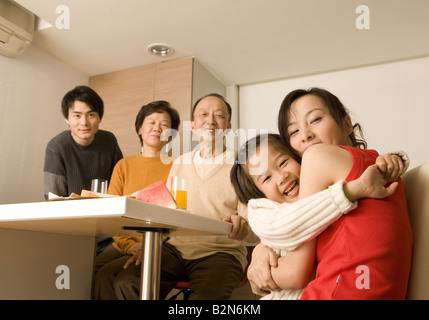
[15,0,429,85]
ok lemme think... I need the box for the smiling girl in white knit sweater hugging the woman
[231,134,397,299]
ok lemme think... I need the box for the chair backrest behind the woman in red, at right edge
[403,163,429,300]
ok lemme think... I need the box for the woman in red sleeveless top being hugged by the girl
[248,88,412,299]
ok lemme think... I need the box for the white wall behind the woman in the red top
[240,57,429,168]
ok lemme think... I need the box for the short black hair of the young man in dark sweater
[61,86,104,120]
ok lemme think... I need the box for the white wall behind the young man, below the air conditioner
[0,45,89,204]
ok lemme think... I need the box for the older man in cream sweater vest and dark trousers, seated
[115,94,257,300]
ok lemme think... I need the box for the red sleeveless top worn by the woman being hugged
[301,146,412,299]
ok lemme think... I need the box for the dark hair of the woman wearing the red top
[278,88,367,149]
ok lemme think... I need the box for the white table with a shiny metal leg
[0,197,231,299]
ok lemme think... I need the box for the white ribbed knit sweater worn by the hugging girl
[248,181,357,300]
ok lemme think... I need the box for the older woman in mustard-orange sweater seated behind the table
[94,101,180,300]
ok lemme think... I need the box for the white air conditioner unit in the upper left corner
[0,0,36,58]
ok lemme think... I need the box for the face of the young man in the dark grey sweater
[65,100,100,146]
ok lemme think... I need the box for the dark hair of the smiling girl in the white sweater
[230,133,300,205]
